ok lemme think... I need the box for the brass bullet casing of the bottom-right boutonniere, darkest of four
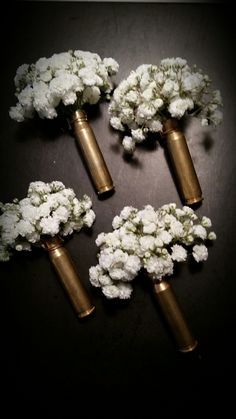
[154,281,197,352]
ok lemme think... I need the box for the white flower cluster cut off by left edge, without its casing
[0,181,95,261]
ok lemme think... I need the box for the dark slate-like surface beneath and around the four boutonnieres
[0,2,236,418]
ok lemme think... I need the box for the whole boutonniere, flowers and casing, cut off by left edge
[0,181,95,317]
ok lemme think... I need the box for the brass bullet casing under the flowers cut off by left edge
[42,236,95,318]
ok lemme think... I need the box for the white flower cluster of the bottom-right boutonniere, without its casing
[89,203,216,299]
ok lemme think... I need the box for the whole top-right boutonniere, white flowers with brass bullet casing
[109,58,222,205]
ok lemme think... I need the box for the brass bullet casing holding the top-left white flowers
[70,111,114,195]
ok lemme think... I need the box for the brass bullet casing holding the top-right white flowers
[163,118,203,205]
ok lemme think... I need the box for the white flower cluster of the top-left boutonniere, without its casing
[10,50,119,122]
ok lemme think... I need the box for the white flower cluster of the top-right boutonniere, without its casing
[109,57,223,154]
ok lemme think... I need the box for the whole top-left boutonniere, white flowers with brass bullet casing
[9,50,119,194]
